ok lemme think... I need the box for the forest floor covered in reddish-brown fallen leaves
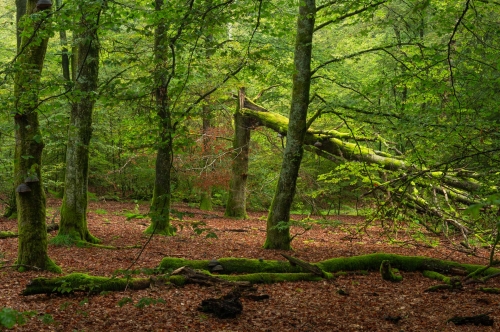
[0,200,500,332]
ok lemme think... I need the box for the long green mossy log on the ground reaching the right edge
[159,253,500,276]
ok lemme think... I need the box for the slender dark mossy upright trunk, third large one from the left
[145,0,174,235]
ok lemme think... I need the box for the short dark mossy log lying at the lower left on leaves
[22,273,152,296]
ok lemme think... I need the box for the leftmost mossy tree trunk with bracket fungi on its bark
[14,0,60,272]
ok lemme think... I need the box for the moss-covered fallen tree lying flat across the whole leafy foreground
[22,253,500,295]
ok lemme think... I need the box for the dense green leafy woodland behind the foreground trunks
[0,1,500,230]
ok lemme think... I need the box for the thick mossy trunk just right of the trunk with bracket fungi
[54,2,101,243]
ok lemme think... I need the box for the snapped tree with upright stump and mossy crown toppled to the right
[226,89,497,248]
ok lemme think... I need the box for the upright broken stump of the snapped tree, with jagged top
[225,88,250,219]
